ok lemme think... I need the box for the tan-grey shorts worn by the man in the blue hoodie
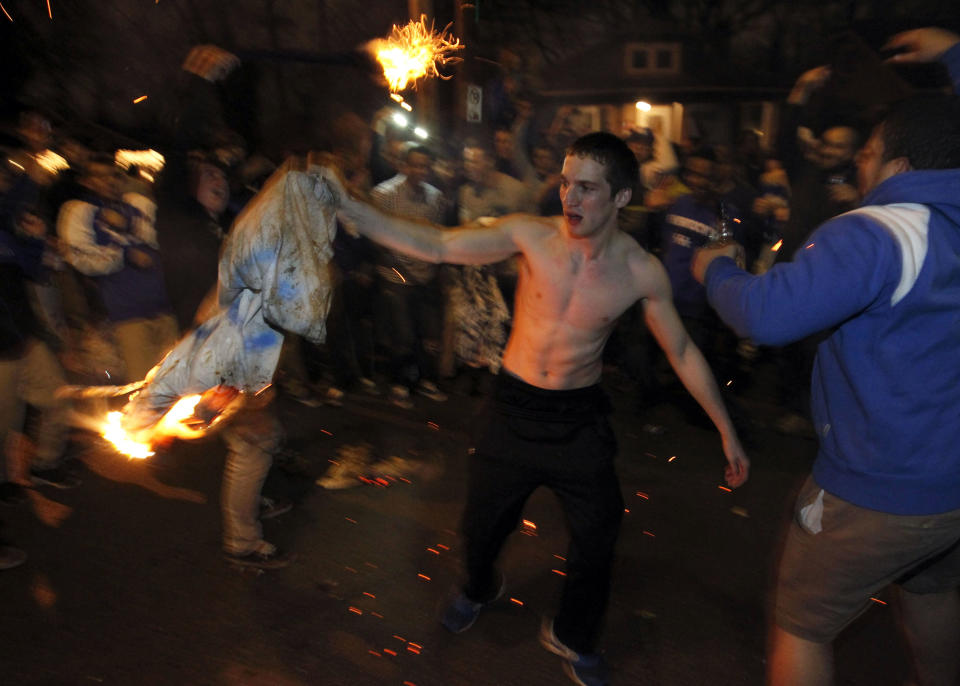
[775,477,960,643]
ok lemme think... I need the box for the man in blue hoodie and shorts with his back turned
[692,29,960,686]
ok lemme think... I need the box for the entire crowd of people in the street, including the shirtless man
[0,29,960,686]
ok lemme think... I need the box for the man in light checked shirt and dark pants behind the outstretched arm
[370,144,447,409]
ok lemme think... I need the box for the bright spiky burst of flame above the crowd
[368,14,463,93]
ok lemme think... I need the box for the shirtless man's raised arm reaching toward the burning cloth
[321,169,530,264]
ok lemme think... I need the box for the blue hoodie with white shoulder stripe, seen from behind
[706,169,960,515]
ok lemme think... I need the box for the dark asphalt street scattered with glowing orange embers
[0,362,908,686]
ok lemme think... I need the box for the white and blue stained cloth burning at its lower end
[123,160,337,433]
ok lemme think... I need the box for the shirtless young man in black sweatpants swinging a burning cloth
[331,133,749,686]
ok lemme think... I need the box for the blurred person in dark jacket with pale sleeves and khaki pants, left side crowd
[57,157,177,382]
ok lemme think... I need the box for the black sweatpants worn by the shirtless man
[463,373,623,653]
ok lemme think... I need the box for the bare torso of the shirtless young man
[503,218,650,390]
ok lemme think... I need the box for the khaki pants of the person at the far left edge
[0,340,69,481]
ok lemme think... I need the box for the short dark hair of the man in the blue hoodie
[880,95,960,169]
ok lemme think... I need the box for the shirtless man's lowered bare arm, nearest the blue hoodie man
[643,262,750,488]
